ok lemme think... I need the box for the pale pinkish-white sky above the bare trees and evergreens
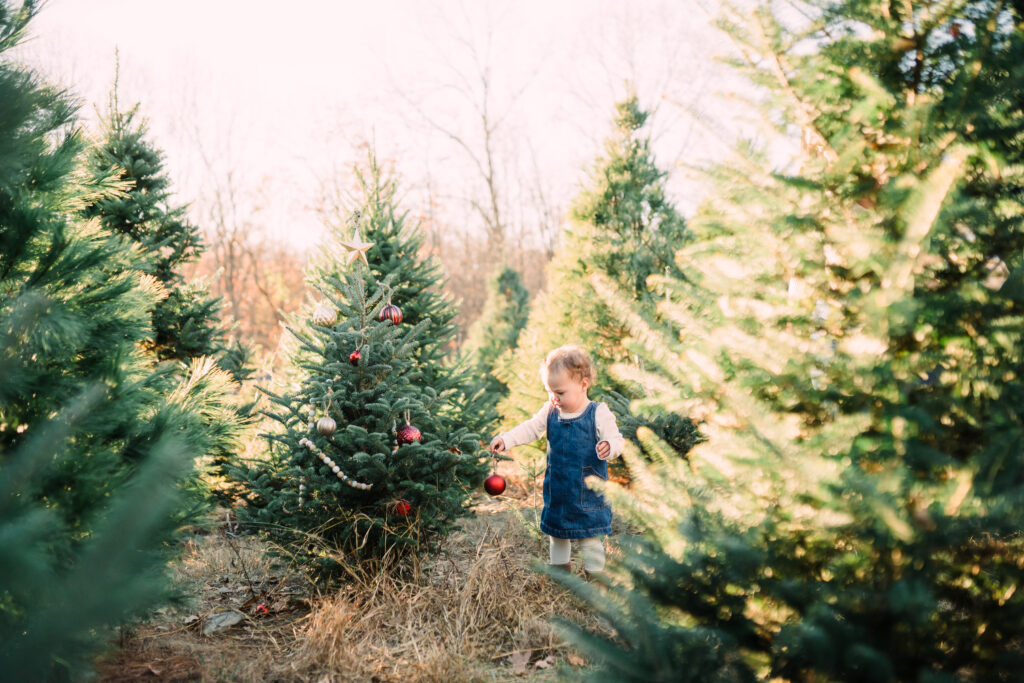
[6,0,761,247]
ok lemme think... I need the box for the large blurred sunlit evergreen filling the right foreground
[557,2,1024,681]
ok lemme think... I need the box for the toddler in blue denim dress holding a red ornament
[490,345,624,573]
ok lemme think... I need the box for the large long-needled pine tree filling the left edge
[0,1,238,680]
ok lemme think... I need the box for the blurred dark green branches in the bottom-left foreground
[0,387,197,681]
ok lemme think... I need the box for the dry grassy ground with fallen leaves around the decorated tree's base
[97,464,596,683]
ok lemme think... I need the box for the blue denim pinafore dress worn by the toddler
[541,401,611,539]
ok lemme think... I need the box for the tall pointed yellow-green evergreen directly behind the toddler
[496,95,695,458]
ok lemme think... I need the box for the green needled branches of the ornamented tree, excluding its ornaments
[236,266,482,578]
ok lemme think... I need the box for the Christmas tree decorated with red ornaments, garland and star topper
[234,205,483,579]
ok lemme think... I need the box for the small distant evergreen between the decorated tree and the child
[463,267,529,422]
